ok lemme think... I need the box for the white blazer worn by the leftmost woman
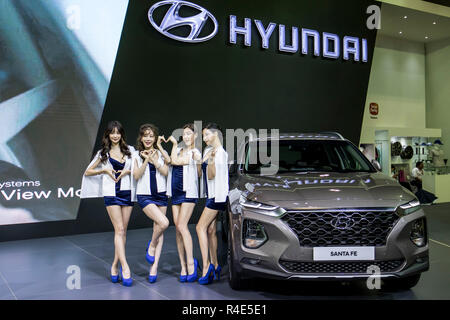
[81,146,136,201]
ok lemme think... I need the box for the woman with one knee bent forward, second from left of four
[132,124,170,283]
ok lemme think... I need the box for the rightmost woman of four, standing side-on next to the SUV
[196,123,228,284]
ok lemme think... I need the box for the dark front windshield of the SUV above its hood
[244,140,375,174]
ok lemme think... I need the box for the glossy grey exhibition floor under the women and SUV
[0,204,450,300]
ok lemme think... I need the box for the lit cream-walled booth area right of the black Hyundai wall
[360,4,450,203]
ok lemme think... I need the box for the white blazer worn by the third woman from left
[167,147,201,198]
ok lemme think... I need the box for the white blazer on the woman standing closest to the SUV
[200,146,229,202]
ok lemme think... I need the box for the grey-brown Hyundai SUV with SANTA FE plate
[224,133,429,289]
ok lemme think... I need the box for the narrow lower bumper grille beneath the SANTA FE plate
[280,260,405,274]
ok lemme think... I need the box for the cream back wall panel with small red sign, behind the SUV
[362,35,426,136]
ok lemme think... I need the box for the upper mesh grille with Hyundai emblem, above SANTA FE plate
[282,210,399,247]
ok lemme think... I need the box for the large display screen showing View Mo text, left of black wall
[0,0,128,225]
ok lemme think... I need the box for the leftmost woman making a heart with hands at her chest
[81,121,135,286]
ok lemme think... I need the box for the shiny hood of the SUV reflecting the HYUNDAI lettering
[239,172,415,209]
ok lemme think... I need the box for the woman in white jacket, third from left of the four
[167,123,202,282]
